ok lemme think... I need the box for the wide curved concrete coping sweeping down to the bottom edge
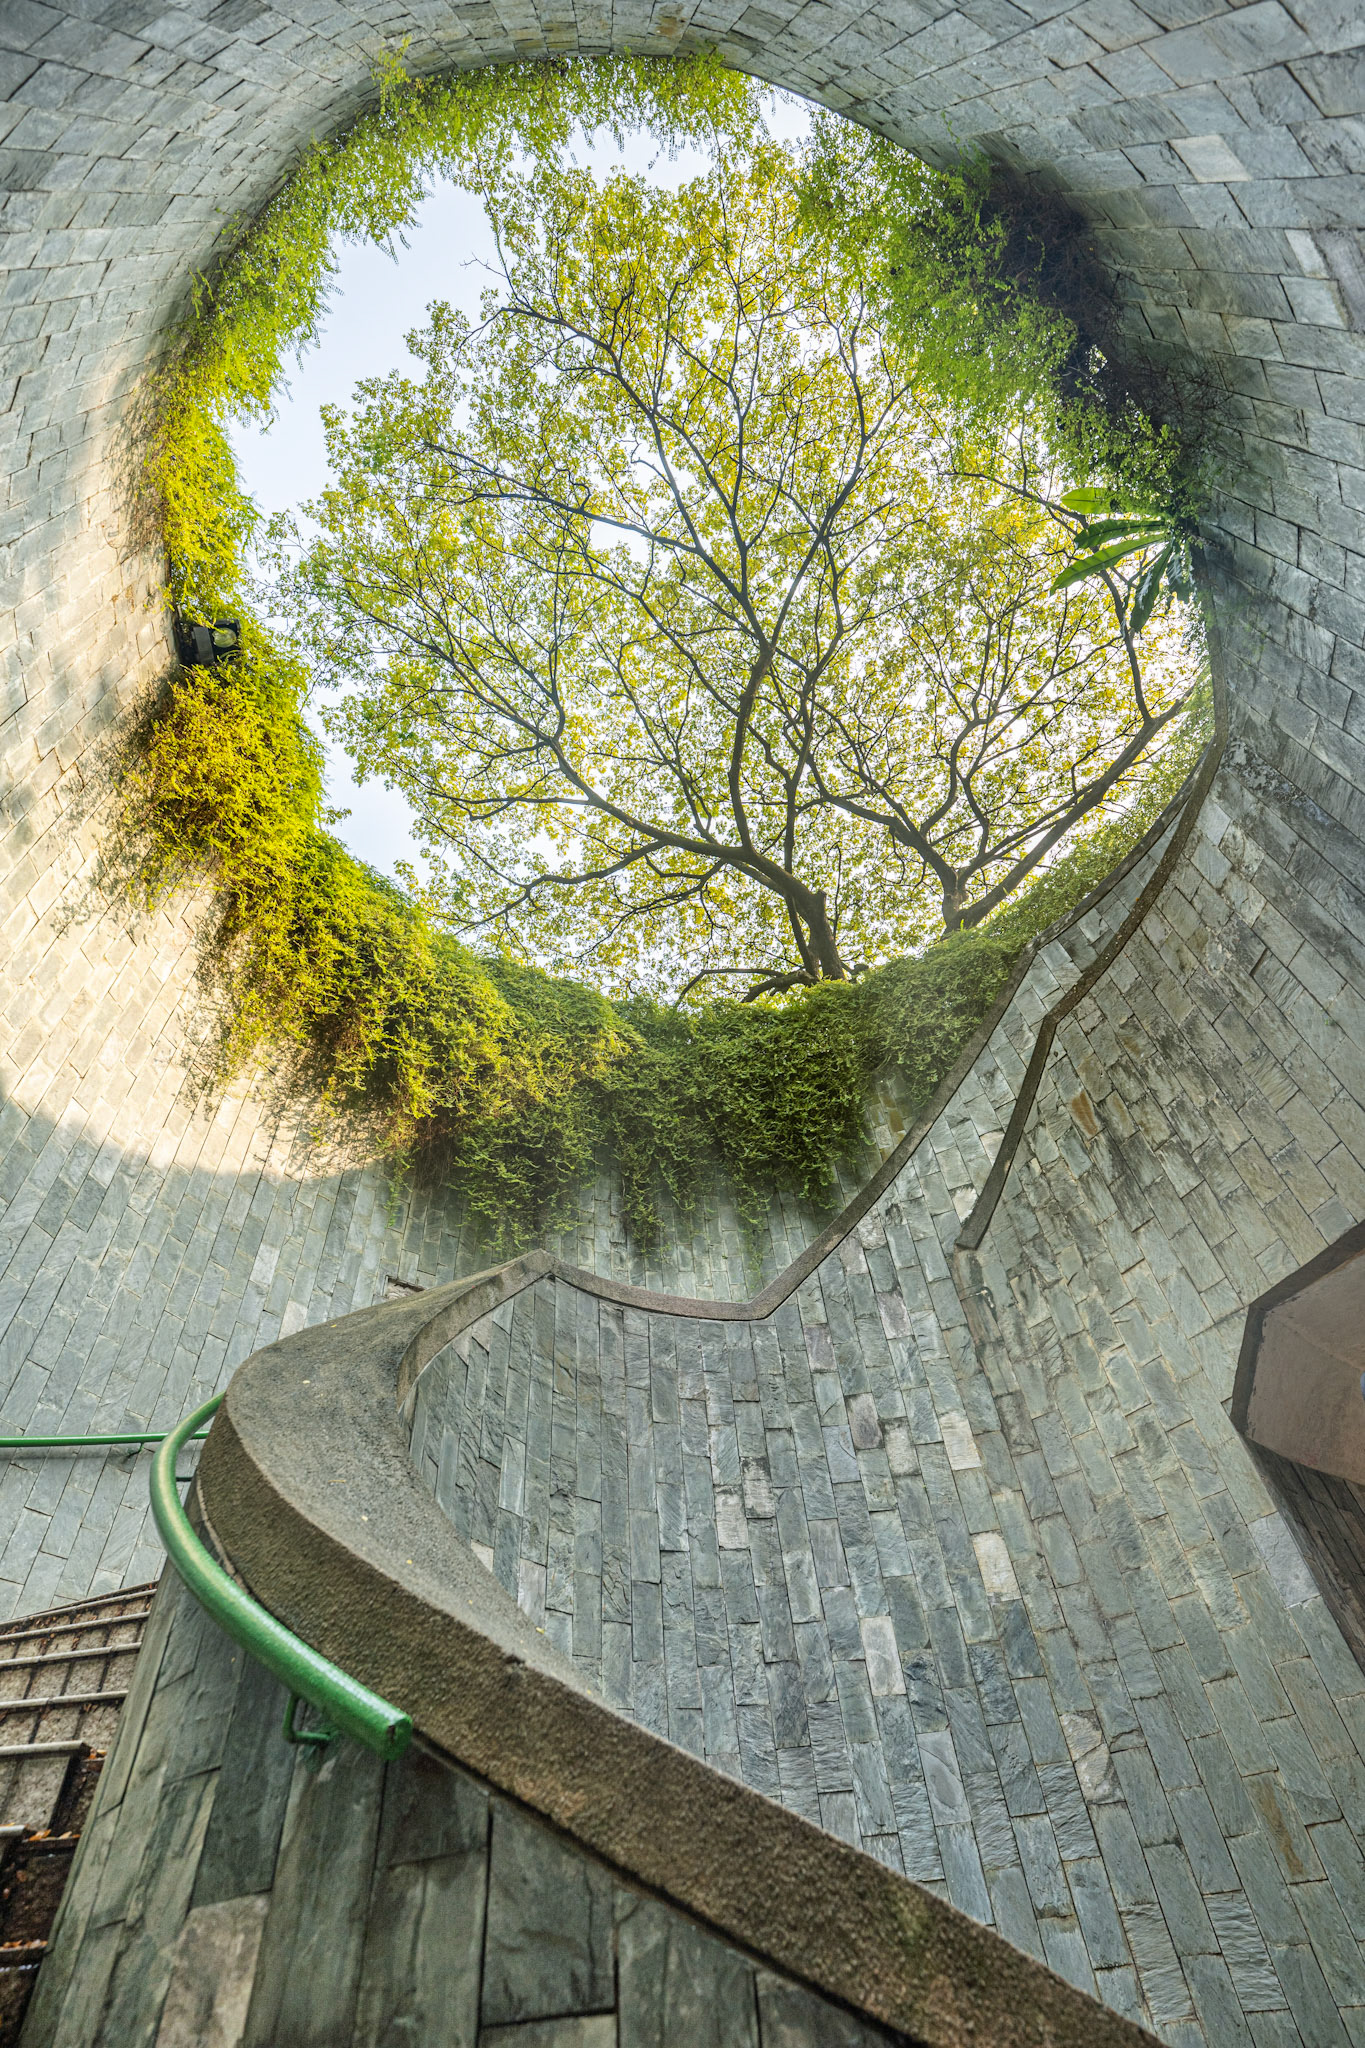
[199,1286,1152,2048]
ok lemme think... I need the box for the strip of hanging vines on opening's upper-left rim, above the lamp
[143,57,755,618]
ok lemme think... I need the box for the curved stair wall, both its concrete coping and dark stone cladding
[23,1272,1146,2048]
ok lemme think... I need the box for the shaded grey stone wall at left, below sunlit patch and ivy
[0,1063,843,1618]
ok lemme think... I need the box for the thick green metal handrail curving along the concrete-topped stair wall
[151,1395,411,1761]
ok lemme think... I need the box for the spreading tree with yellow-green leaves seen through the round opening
[287,145,1193,997]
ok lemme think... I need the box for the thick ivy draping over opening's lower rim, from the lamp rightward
[125,631,1185,1251]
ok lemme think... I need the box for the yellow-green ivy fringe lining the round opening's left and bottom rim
[123,59,1203,1251]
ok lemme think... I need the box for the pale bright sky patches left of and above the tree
[231,92,810,874]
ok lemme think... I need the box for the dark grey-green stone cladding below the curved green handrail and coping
[23,1577,892,2048]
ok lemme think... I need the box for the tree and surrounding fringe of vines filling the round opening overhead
[125,61,1203,1243]
